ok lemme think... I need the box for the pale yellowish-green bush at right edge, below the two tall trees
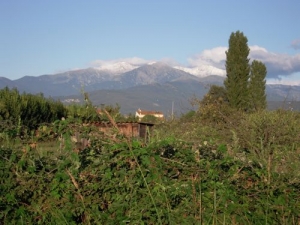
[236,110,300,160]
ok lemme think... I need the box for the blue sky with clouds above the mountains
[0,0,300,85]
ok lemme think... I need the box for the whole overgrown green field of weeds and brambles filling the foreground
[0,110,300,224]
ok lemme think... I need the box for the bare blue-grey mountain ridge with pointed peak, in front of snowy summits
[0,63,199,97]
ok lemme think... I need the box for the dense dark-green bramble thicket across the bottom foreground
[0,117,300,224]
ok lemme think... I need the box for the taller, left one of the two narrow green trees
[224,31,250,110]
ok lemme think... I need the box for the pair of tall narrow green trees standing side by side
[224,31,267,112]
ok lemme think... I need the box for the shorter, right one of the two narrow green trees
[249,60,267,111]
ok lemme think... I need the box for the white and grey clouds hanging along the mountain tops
[87,44,300,84]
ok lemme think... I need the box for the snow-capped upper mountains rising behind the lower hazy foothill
[0,61,300,108]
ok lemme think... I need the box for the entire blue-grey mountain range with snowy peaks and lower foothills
[0,62,300,115]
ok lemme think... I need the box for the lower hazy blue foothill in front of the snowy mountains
[89,80,207,115]
